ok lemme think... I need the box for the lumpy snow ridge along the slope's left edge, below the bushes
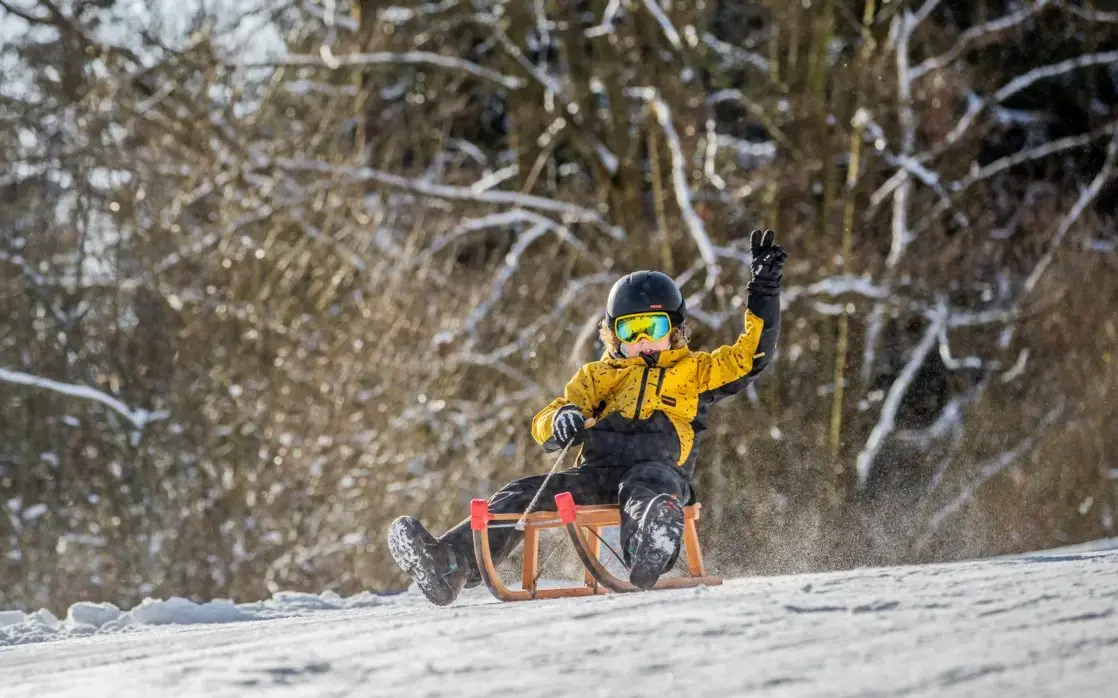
[0,592,404,648]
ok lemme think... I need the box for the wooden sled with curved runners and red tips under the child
[470,492,722,601]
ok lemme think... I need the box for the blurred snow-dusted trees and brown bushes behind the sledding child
[0,0,1118,606]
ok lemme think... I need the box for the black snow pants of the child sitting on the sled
[442,462,693,582]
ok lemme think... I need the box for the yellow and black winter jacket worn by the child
[532,298,780,477]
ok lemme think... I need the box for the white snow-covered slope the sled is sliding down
[0,549,1118,698]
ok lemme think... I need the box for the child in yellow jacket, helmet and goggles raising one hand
[388,230,787,605]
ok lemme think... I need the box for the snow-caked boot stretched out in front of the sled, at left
[388,517,472,606]
